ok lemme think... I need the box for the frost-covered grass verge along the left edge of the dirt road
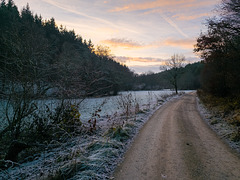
[0,92,178,180]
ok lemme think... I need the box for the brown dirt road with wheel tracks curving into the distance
[114,93,240,180]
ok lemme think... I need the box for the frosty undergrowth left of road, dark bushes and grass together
[0,90,177,180]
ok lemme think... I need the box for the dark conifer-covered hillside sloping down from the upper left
[0,0,133,98]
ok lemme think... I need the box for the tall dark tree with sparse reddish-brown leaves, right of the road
[194,0,240,97]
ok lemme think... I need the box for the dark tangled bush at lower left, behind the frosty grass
[1,102,85,165]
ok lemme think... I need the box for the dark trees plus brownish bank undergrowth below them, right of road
[194,0,240,142]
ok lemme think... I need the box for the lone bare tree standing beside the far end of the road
[163,54,185,94]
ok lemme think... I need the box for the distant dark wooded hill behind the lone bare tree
[133,62,204,90]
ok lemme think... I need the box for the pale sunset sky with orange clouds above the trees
[14,0,220,74]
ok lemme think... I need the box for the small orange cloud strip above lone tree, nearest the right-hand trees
[163,38,196,49]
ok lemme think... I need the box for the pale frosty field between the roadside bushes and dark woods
[0,90,172,129]
